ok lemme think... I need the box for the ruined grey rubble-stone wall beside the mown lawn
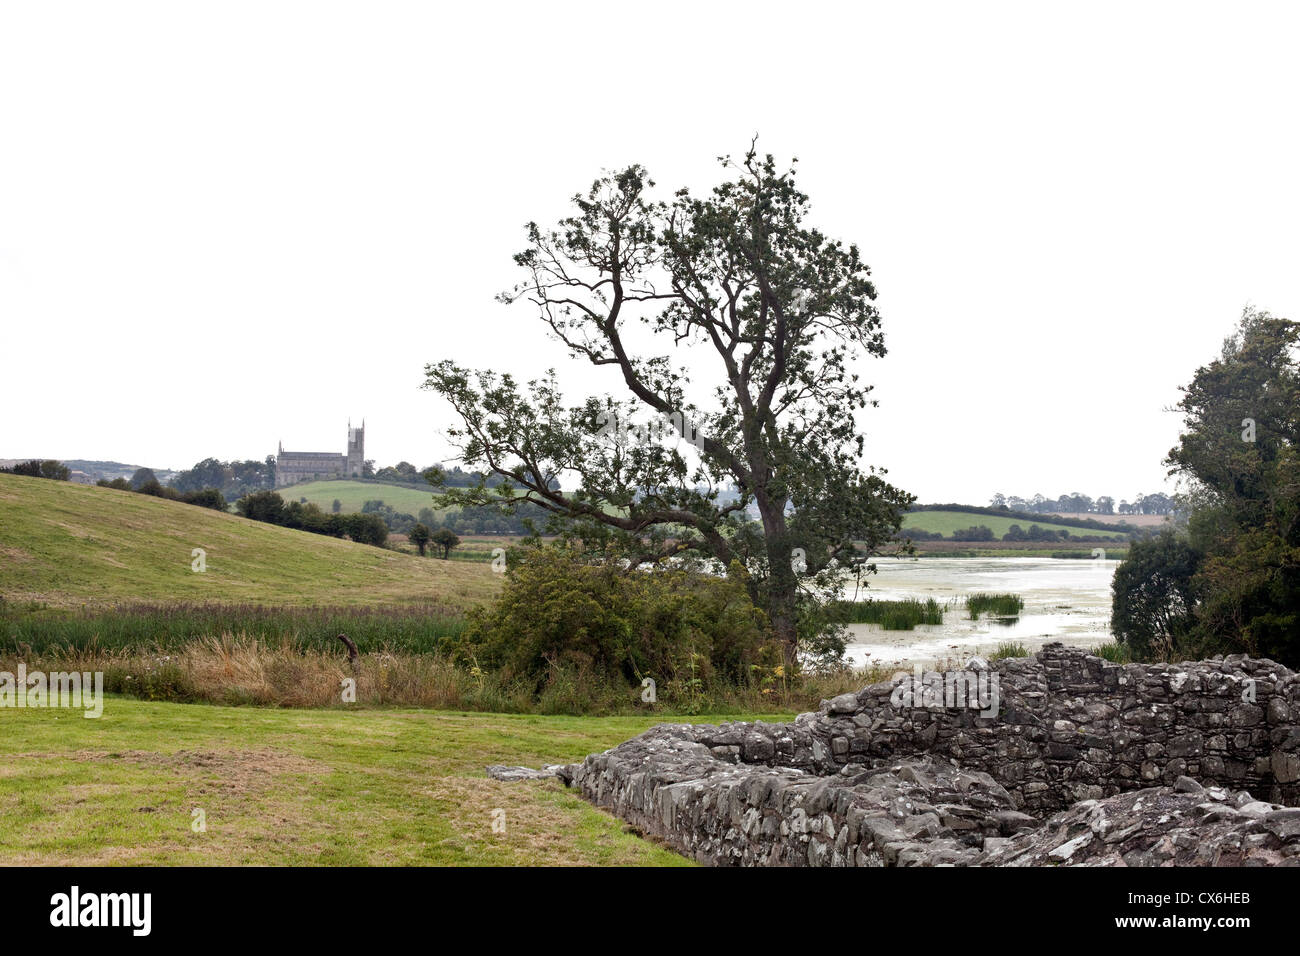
[572,645,1300,865]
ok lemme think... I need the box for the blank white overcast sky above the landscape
[0,0,1300,503]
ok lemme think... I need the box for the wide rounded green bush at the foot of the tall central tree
[460,546,771,692]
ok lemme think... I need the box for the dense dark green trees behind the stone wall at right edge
[1112,310,1300,667]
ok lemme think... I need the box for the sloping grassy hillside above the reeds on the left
[0,475,498,607]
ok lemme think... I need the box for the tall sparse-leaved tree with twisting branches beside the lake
[425,148,913,657]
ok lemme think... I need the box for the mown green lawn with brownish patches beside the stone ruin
[0,697,789,866]
